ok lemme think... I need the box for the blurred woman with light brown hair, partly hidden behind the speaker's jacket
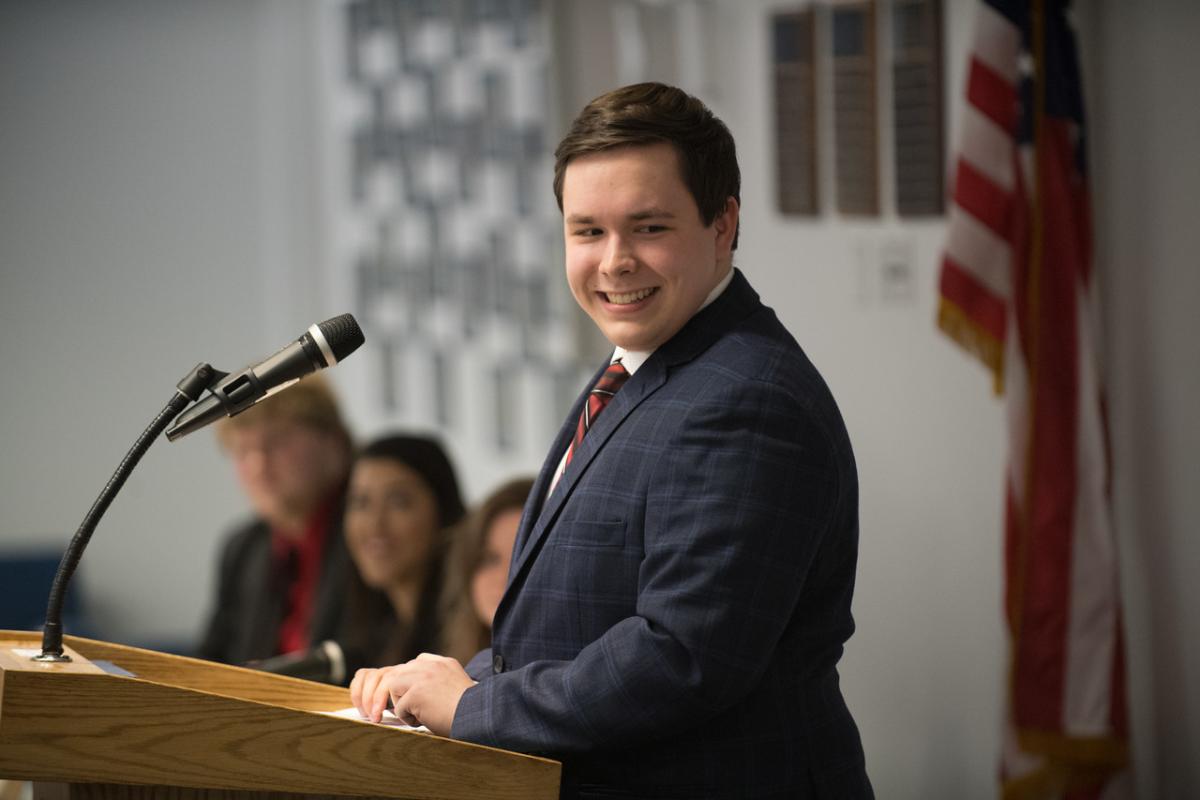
[439,477,533,663]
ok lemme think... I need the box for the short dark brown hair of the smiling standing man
[554,83,742,248]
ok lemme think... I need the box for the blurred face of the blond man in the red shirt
[226,420,346,528]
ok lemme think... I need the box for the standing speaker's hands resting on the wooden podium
[350,652,475,736]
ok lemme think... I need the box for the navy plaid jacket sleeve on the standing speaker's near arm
[452,381,857,753]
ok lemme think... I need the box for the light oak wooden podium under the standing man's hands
[0,631,560,800]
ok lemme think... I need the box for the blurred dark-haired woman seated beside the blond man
[341,435,463,678]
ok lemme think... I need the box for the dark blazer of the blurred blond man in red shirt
[197,505,350,664]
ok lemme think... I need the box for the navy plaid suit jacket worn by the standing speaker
[452,272,871,800]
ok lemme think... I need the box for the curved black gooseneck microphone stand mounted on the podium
[34,363,227,661]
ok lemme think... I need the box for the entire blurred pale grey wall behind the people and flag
[0,0,1200,799]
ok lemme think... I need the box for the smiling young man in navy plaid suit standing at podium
[352,84,871,800]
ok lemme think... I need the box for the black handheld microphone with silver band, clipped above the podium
[167,314,365,441]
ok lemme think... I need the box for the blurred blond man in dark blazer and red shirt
[197,375,353,663]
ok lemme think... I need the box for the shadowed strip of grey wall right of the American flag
[1081,0,1200,799]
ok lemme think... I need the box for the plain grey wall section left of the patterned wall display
[0,0,331,643]
